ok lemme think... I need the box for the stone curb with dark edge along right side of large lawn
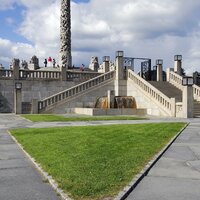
[114,123,189,200]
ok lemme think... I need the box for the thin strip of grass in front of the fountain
[21,114,146,122]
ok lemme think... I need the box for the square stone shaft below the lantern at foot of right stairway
[182,86,194,118]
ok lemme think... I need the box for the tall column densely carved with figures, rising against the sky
[60,0,72,68]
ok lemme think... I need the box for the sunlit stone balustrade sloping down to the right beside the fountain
[128,70,176,116]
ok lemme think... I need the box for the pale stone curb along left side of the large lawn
[7,130,72,200]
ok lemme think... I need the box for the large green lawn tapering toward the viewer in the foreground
[11,123,185,200]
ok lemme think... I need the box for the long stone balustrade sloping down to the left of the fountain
[38,71,115,113]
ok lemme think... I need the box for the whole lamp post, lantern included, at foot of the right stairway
[182,76,194,118]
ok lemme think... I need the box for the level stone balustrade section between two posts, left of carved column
[19,70,61,80]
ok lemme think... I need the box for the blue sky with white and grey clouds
[0,0,200,72]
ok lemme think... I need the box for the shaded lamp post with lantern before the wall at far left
[14,82,22,114]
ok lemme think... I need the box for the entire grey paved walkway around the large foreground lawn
[0,114,200,200]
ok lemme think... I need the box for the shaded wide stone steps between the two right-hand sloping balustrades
[149,81,182,102]
